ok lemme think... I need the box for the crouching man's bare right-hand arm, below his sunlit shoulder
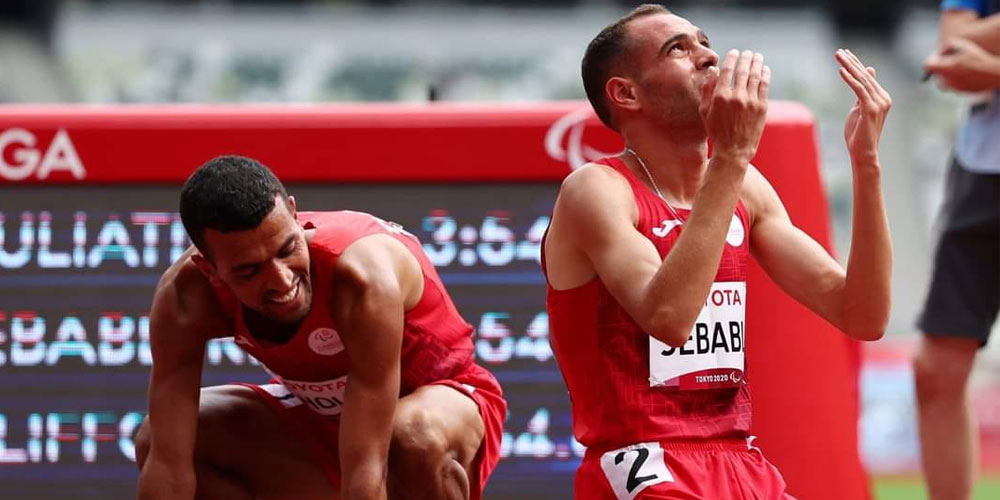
[332,235,423,500]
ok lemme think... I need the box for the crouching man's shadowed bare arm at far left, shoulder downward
[139,249,232,500]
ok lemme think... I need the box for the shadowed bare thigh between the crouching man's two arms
[195,385,338,500]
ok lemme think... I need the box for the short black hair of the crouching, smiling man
[180,155,288,256]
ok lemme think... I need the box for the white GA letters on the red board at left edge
[0,128,87,181]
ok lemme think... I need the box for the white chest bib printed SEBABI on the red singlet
[649,281,747,390]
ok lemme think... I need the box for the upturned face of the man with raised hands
[626,14,719,126]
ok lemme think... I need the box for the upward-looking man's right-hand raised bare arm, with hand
[744,52,892,340]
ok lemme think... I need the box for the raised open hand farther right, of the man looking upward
[836,49,892,167]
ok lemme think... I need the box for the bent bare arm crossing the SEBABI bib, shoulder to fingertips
[546,51,770,346]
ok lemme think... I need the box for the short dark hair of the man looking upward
[580,3,670,130]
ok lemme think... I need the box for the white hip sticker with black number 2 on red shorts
[601,443,674,500]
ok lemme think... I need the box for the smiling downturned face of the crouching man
[201,196,312,323]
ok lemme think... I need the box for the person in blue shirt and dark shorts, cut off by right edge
[913,0,1000,500]
